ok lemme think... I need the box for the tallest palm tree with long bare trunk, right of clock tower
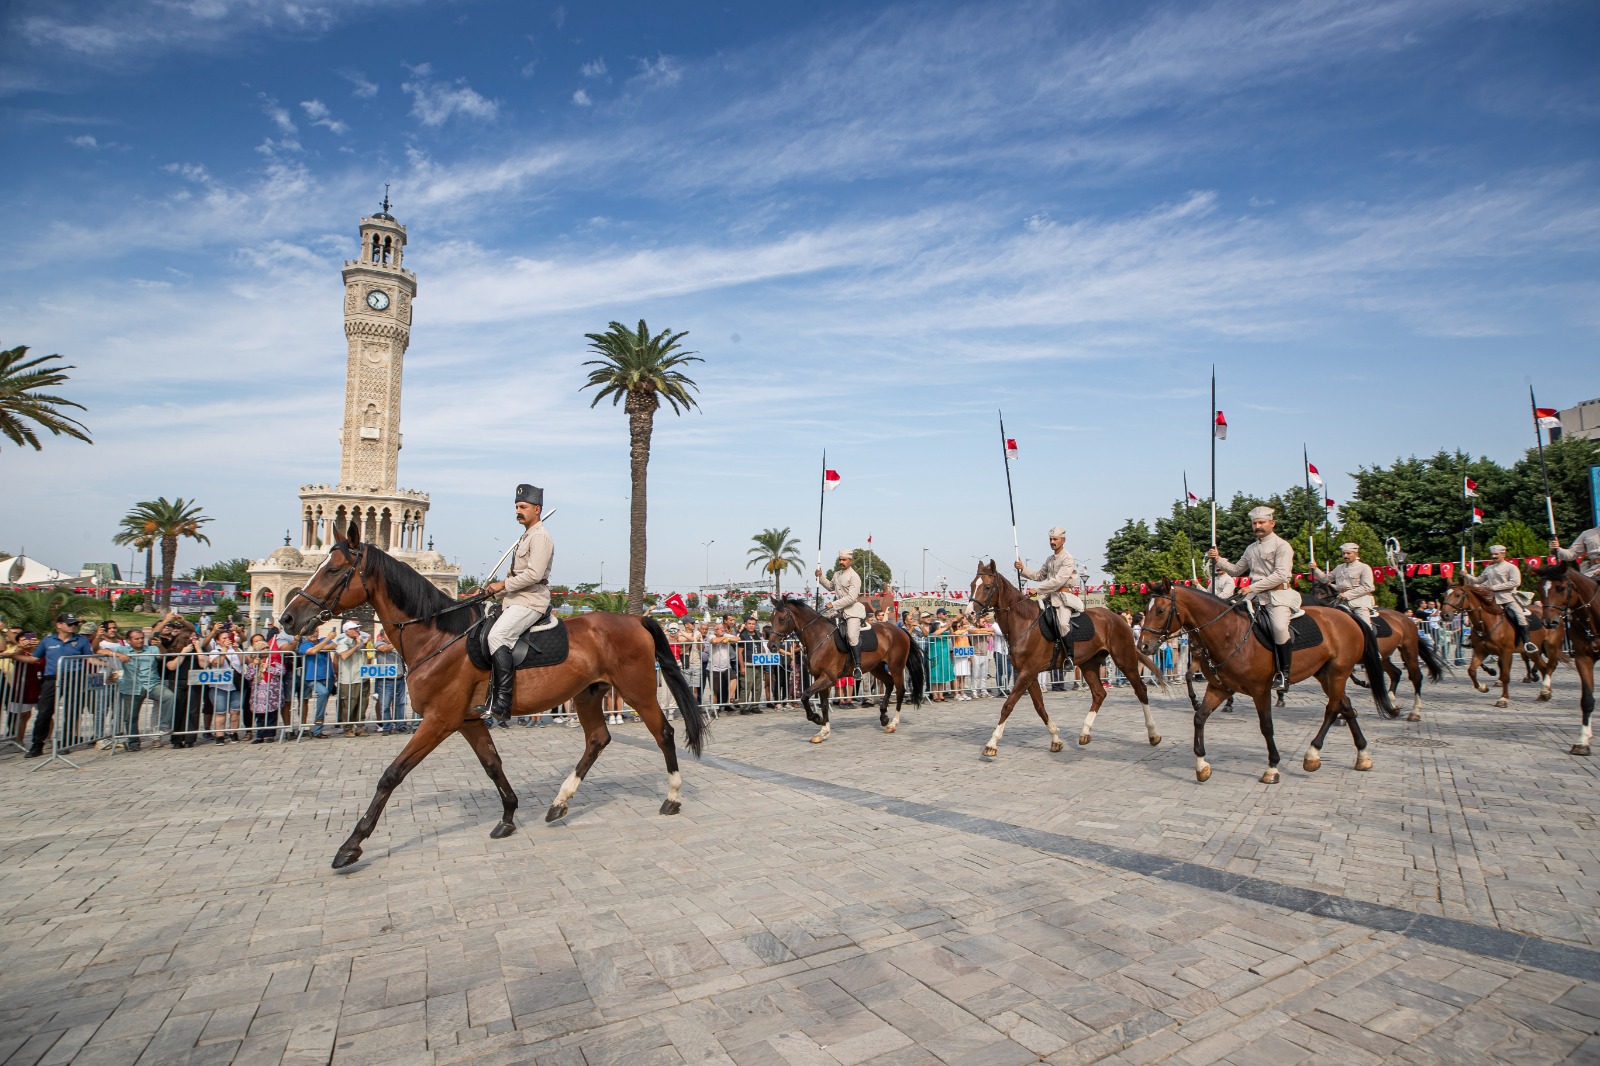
[579,319,704,615]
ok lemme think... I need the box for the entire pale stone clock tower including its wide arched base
[250,195,461,624]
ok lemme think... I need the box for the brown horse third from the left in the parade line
[968,559,1166,759]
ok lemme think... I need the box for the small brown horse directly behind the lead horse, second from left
[768,597,926,744]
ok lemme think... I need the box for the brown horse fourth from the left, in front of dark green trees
[1139,581,1400,784]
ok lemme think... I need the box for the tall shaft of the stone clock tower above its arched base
[339,195,416,491]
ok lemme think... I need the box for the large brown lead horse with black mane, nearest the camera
[280,522,706,869]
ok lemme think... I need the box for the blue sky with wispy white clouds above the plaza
[0,0,1600,589]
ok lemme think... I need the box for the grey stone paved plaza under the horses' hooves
[0,671,1600,1066]
